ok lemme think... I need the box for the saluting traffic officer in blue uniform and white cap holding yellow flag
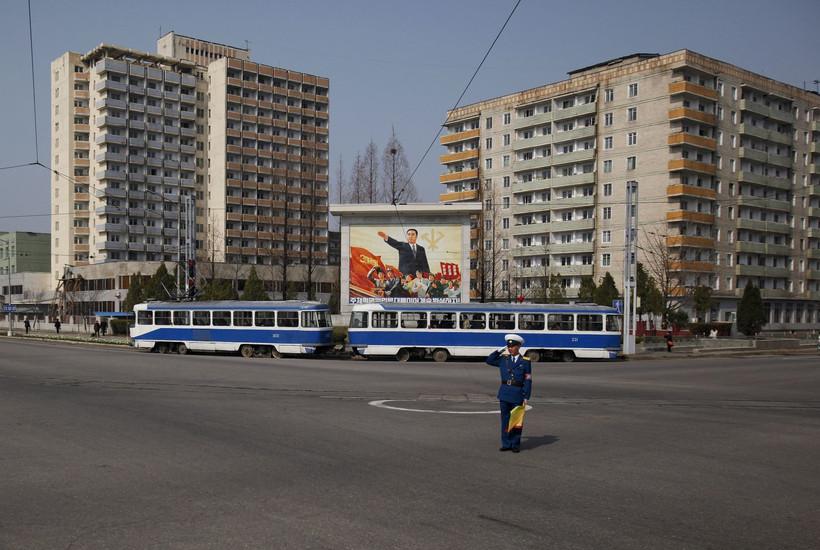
[487,334,532,453]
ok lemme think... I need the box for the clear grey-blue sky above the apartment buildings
[0,0,820,231]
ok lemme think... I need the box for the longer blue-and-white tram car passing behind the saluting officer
[348,303,621,361]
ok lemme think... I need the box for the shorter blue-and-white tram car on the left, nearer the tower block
[131,301,333,357]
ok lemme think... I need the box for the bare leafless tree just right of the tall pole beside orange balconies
[638,229,687,322]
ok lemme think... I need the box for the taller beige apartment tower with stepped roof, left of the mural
[51,32,335,314]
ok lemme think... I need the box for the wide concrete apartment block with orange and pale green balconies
[440,50,820,329]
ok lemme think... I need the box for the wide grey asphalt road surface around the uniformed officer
[0,340,820,549]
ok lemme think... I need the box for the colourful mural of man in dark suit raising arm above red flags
[348,224,463,304]
